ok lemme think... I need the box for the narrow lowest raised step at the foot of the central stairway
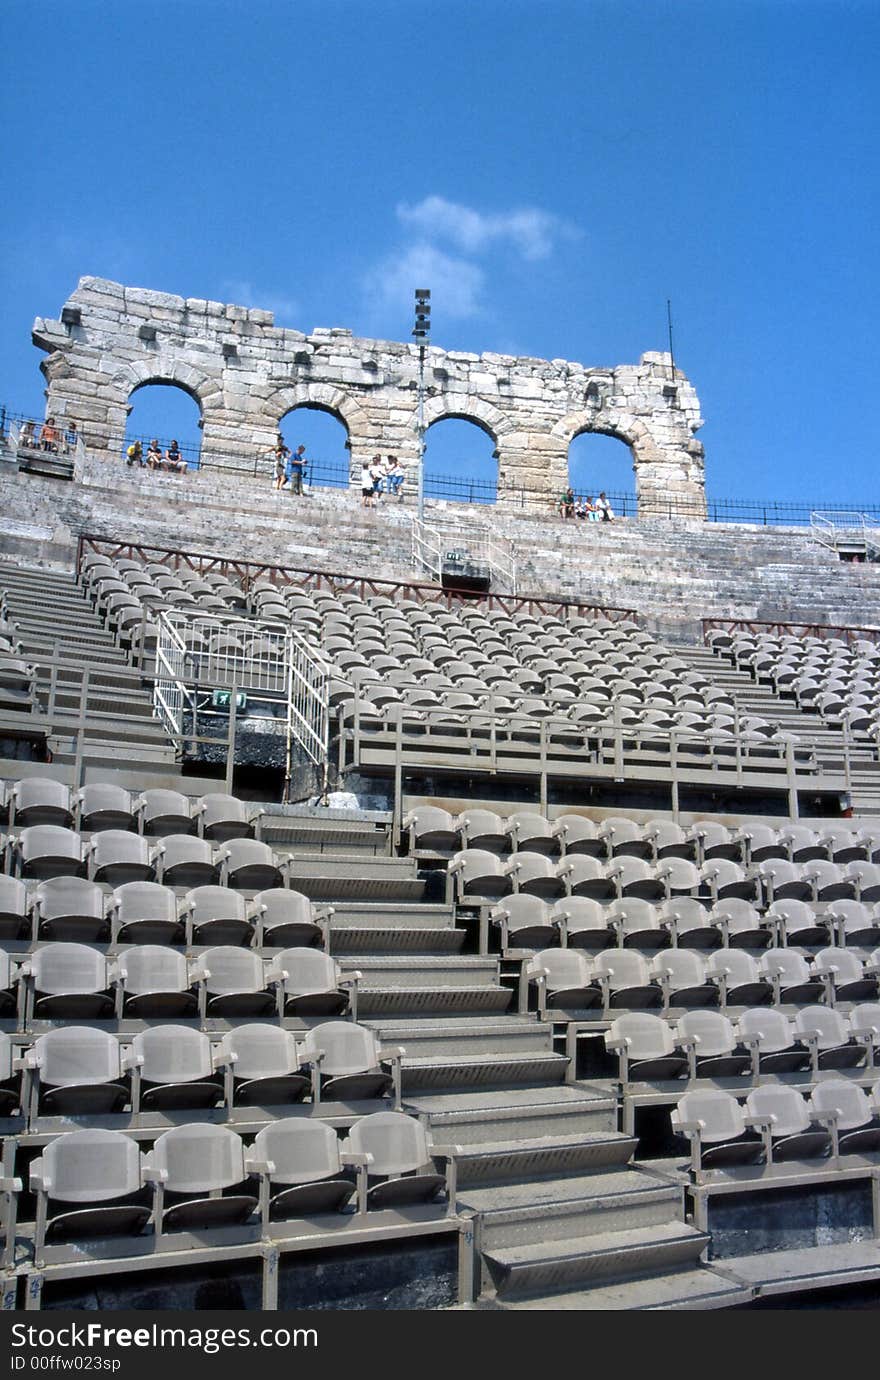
[483,1221,709,1299]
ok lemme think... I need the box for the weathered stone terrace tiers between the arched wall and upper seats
[0,457,880,642]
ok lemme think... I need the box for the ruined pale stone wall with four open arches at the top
[33,277,705,518]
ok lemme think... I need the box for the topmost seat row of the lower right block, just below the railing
[403,806,880,864]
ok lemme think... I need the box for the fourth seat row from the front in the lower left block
[0,875,331,948]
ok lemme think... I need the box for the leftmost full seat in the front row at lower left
[30,1129,150,1263]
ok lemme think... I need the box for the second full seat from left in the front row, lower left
[143,1125,259,1238]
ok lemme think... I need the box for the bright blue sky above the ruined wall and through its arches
[0,0,880,502]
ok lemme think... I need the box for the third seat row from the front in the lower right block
[520,948,880,1018]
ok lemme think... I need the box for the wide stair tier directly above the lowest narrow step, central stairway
[459,1169,684,1252]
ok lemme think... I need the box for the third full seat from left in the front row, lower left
[248,1118,360,1221]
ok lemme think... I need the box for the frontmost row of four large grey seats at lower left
[7,1112,455,1263]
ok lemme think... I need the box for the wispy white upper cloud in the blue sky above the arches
[396,196,578,261]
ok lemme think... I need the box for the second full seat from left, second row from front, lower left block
[131,1025,223,1112]
